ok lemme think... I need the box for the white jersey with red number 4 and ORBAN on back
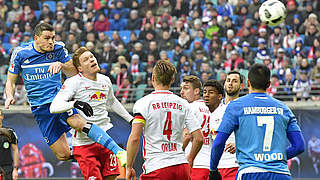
[133,90,200,174]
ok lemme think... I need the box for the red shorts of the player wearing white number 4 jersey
[140,164,190,180]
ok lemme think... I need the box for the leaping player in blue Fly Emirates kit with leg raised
[5,23,126,161]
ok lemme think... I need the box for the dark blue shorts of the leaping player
[31,103,78,146]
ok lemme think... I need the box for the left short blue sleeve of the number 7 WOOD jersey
[217,101,239,134]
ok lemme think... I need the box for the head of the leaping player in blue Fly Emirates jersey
[33,23,55,53]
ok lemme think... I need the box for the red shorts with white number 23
[73,143,120,180]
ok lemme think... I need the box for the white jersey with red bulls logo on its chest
[56,73,115,146]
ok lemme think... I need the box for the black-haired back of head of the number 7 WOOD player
[248,64,270,91]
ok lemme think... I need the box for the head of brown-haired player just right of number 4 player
[180,75,202,103]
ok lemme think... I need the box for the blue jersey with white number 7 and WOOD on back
[218,93,301,174]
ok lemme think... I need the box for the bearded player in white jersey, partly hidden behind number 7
[210,71,243,180]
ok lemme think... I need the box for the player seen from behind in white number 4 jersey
[126,60,203,180]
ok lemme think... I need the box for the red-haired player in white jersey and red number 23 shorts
[50,47,133,179]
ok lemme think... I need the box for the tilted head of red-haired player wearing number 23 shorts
[72,47,100,74]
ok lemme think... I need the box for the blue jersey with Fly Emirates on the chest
[9,41,71,106]
